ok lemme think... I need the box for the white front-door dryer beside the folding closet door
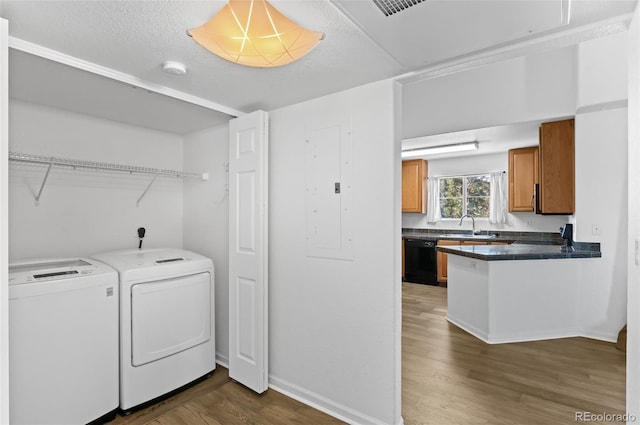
[94,249,216,413]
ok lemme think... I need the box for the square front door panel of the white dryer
[131,273,212,366]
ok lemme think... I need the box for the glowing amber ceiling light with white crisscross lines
[187,0,324,68]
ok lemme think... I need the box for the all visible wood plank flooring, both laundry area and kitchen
[111,283,625,425]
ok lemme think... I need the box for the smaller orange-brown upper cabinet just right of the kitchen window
[509,146,538,212]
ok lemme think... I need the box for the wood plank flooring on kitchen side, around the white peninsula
[402,283,625,425]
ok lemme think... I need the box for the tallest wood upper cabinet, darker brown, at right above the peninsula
[538,118,575,214]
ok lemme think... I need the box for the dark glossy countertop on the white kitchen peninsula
[436,243,602,261]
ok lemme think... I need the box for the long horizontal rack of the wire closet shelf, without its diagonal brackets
[9,152,209,180]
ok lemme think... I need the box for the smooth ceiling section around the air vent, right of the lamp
[338,0,562,71]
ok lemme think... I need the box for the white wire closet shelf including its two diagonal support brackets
[9,152,209,205]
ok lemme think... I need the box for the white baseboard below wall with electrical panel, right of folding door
[269,375,404,425]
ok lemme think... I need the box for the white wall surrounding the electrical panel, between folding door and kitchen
[269,81,401,424]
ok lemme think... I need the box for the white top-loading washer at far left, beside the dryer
[9,258,118,425]
